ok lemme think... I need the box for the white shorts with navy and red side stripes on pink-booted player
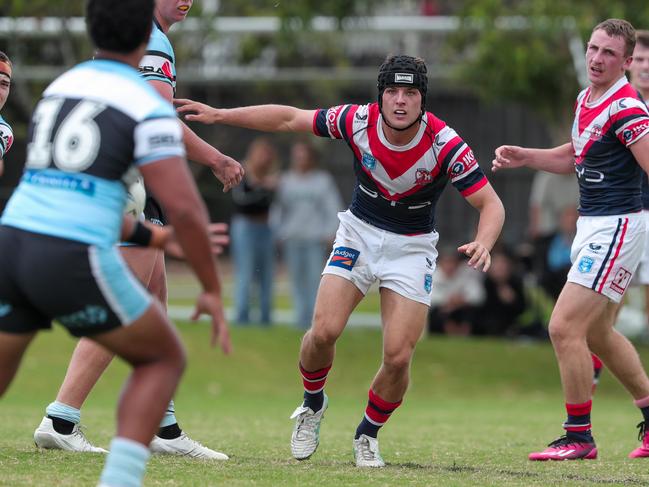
[568,213,645,303]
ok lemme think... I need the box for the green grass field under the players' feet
[0,324,649,486]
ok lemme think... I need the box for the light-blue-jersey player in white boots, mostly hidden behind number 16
[34,0,243,460]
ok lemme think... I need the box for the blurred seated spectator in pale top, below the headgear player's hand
[428,248,484,336]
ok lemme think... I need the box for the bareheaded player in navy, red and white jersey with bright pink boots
[493,19,649,460]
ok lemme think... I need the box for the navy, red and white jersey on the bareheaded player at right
[572,76,649,216]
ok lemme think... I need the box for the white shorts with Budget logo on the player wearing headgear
[322,210,439,305]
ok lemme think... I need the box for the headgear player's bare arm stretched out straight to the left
[174,99,316,132]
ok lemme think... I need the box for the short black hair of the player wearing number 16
[86,0,154,54]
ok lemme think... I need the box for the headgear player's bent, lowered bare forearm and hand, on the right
[457,183,505,272]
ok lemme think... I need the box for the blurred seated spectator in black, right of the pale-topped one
[475,248,525,336]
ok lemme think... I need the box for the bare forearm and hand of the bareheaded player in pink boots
[491,142,575,174]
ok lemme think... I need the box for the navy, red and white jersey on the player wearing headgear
[313,103,487,235]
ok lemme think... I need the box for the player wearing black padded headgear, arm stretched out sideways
[176,56,505,467]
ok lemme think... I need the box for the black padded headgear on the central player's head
[376,55,428,113]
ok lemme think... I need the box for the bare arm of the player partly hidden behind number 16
[149,80,244,192]
